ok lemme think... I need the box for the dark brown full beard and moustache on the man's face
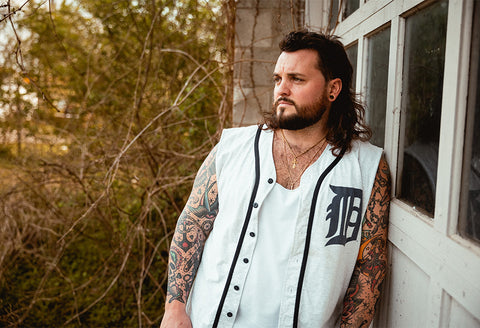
[272,95,327,130]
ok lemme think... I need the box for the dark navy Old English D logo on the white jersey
[325,185,362,246]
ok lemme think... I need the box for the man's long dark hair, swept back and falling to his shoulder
[265,30,372,154]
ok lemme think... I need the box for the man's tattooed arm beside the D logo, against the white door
[341,156,390,327]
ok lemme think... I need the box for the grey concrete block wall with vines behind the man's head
[232,0,304,126]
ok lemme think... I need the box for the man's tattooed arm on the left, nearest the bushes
[161,148,218,328]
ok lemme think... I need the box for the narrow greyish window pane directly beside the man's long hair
[366,28,390,148]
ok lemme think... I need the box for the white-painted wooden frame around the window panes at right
[305,0,480,327]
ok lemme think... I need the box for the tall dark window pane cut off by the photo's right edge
[459,1,480,242]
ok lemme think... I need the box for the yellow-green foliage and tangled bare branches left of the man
[0,0,229,327]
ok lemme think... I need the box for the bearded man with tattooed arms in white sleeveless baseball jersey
[161,31,390,328]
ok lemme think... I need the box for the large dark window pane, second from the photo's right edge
[400,0,448,217]
